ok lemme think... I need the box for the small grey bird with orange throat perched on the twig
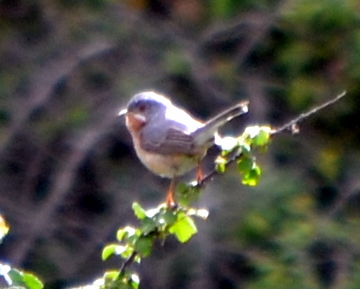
[118,91,248,207]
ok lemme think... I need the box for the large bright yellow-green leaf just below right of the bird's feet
[169,212,197,243]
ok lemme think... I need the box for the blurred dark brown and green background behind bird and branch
[0,0,360,289]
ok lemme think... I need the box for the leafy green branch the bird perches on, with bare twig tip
[73,92,345,289]
